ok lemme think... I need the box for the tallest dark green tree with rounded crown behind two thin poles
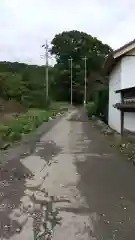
[51,31,112,101]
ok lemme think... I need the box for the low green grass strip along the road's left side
[0,103,67,149]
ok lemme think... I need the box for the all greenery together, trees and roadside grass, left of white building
[0,31,112,148]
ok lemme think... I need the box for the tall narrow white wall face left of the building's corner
[108,62,121,132]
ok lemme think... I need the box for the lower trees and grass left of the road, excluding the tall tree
[0,62,68,149]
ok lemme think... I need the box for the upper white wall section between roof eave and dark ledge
[121,55,135,89]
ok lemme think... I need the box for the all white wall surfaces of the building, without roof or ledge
[108,49,135,132]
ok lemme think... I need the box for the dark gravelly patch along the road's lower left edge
[0,156,31,239]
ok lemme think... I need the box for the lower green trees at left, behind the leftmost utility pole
[0,62,53,108]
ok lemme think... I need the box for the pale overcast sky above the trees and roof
[0,0,135,65]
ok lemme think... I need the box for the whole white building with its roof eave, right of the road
[105,40,135,134]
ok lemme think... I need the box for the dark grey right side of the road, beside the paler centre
[76,111,135,240]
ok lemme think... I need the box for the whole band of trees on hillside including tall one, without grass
[0,30,112,118]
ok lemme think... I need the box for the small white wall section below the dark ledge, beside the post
[124,112,135,132]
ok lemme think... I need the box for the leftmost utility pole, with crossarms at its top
[42,40,49,100]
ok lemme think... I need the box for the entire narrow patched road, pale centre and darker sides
[0,109,135,240]
